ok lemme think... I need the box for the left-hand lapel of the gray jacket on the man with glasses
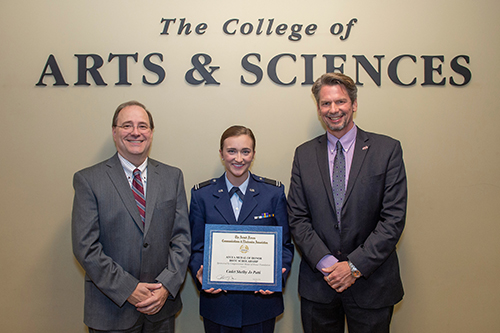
[106,153,147,230]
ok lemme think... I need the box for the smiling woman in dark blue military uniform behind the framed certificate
[189,126,293,333]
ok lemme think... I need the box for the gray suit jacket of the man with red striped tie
[72,154,191,330]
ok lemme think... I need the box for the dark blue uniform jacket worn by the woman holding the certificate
[189,173,294,327]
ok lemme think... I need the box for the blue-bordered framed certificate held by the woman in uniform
[202,224,282,291]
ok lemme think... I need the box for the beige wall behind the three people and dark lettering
[0,0,500,333]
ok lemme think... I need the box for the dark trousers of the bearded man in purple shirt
[300,290,394,333]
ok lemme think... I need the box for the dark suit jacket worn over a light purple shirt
[288,128,407,308]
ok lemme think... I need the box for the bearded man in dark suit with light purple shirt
[288,73,407,333]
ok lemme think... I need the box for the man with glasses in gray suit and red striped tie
[72,101,191,333]
